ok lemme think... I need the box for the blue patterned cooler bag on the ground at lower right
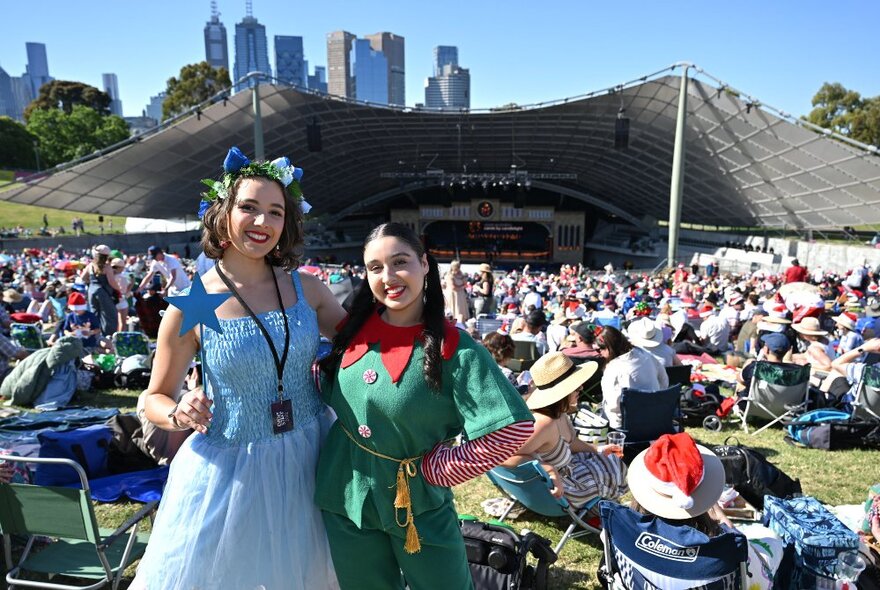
[764,495,859,577]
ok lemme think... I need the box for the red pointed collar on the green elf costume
[340,313,461,383]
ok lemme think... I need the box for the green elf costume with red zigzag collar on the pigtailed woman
[315,313,534,588]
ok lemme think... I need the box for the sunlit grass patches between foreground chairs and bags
[0,389,880,589]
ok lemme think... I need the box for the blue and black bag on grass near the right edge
[785,410,880,451]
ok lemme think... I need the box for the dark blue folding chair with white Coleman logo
[599,502,749,590]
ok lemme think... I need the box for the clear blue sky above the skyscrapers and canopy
[0,0,880,120]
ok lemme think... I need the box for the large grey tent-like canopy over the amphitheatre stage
[6,66,880,229]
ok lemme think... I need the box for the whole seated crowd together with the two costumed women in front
[0,148,880,590]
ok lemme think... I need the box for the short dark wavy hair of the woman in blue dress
[201,176,303,271]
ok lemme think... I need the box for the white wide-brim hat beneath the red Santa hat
[626,445,725,520]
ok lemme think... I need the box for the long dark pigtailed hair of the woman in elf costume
[319,223,446,391]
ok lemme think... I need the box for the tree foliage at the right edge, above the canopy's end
[807,82,880,146]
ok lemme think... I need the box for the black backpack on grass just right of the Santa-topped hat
[712,437,802,510]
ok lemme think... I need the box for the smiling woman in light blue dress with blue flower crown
[132,148,345,590]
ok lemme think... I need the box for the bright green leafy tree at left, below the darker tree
[27,104,129,168]
